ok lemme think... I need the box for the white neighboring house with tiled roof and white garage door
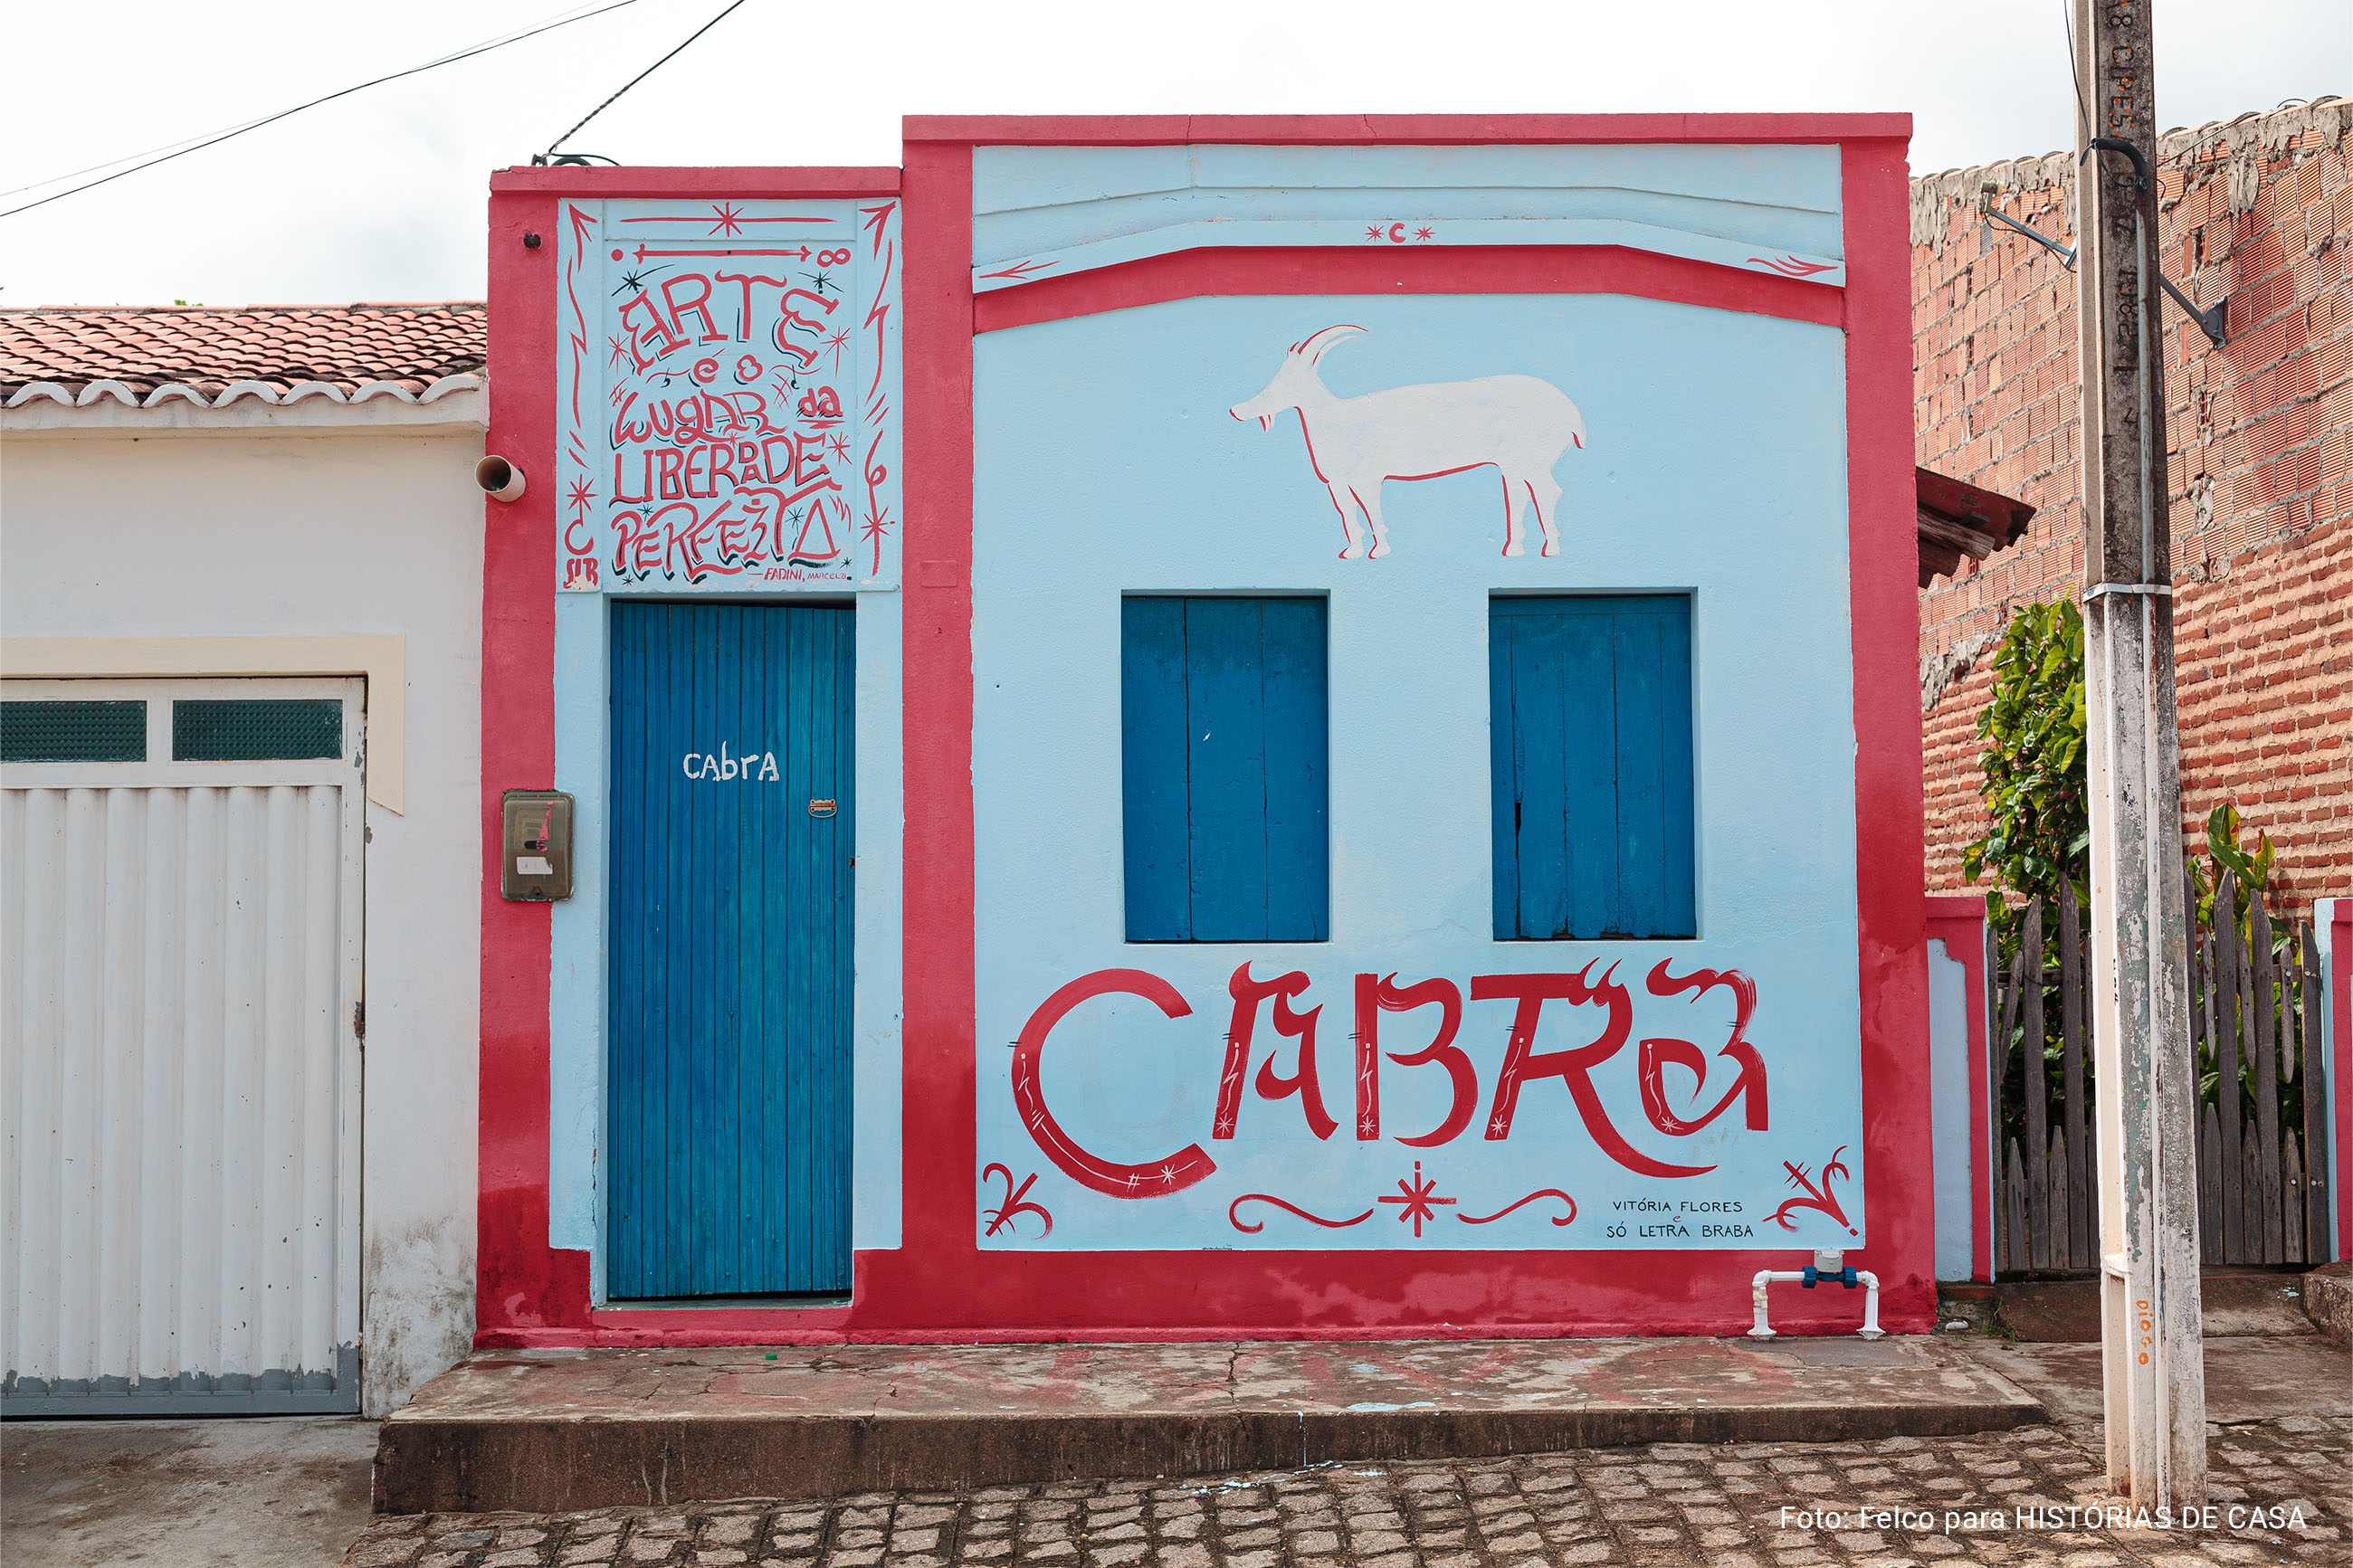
[0,303,487,1415]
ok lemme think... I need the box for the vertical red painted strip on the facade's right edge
[1840,141,1937,1324]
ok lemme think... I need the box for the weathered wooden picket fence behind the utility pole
[1986,877,2329,1274]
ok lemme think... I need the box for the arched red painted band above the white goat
[972,244,1847,331]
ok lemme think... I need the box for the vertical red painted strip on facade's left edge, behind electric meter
[475,195,588,1331]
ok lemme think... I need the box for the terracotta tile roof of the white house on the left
[0,301,487,402]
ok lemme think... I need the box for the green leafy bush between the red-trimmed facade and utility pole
[1960,600,2091,933]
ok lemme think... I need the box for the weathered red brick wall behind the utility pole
[1913,99,2353,912]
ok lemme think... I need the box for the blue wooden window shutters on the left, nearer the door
[1120,597,1329,943]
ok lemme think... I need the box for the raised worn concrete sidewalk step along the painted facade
[374,1337,2043,1514]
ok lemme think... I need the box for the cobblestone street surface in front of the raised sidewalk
[344,1415,2353,1568]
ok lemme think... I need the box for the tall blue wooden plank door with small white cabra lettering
[605,602,856,1300]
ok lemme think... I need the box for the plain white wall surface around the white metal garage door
[0,428,482,1415]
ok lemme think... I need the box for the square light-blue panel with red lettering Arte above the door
[557,200,901,593]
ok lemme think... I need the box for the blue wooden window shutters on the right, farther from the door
[1487,594,1697,938]
